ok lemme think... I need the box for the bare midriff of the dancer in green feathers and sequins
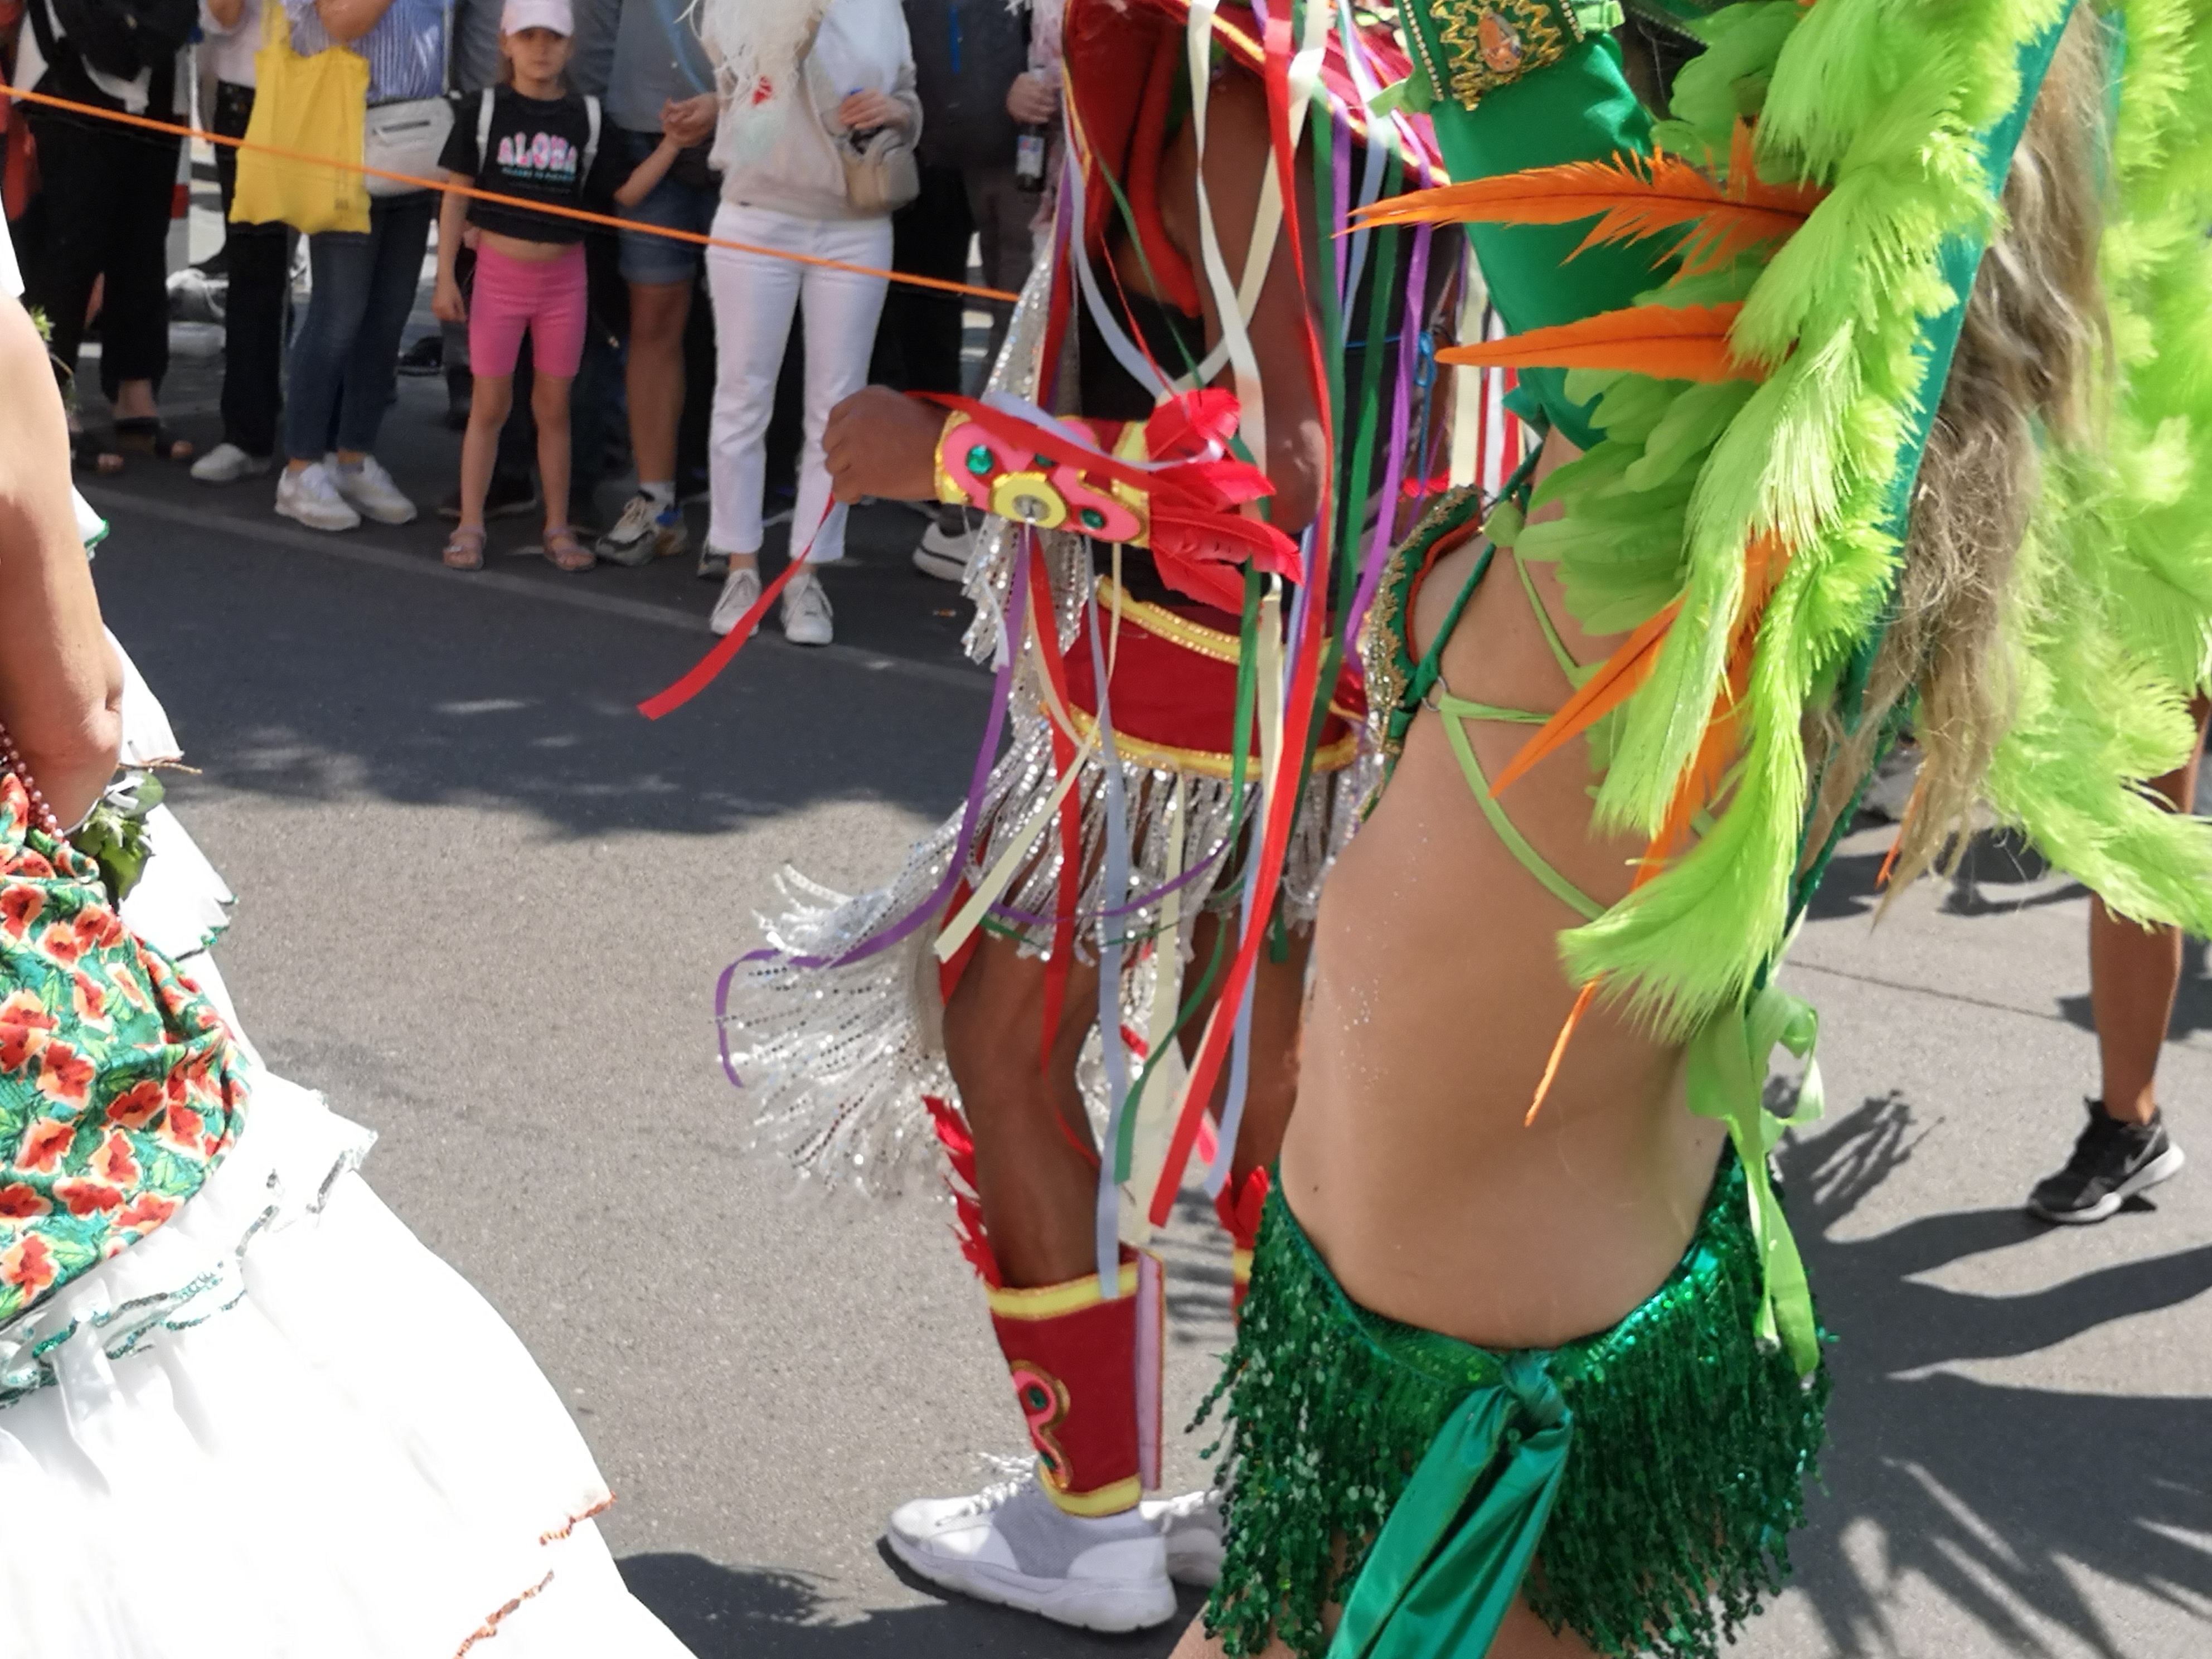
[1280,438,1725,1349]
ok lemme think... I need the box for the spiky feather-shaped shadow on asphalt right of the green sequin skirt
[1781,1095,2212,1659]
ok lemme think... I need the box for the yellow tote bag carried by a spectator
[230,0,370,235]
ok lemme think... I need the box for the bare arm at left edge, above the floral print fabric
[0,299,124,823]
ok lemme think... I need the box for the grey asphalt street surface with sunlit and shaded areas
[69,382,2212,1659]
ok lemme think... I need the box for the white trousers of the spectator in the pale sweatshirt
[706,201,891,564]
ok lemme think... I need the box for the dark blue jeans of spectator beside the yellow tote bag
[283,190,438,460]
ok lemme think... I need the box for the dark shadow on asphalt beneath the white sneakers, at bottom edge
[622,1551,1201,1659]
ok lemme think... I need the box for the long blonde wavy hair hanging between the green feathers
[1805,7,2110,889]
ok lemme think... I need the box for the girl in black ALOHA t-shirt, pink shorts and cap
[431,0,681,571]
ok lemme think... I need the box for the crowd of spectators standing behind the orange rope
[0,0,1058,644]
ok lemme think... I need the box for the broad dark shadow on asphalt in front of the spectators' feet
[95,491,989,836]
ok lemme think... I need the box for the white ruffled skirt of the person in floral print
[0,1071,686,1659]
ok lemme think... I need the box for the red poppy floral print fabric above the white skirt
[0,774,245,1327]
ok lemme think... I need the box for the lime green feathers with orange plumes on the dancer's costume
[1374,0,2212,1037]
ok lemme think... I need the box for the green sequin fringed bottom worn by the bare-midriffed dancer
[1199,1150,1830,1659]
